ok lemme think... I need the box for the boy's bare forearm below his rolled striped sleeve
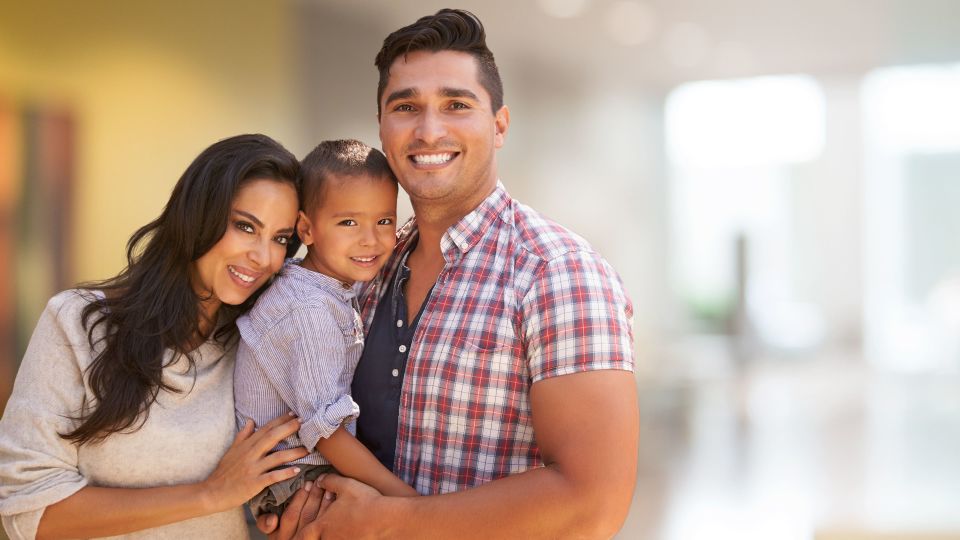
[316,426,417,497]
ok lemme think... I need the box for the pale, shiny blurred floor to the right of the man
[618,342,960,540]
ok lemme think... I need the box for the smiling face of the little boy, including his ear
[297,175,397,285]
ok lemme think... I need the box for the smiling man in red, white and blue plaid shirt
[262,9,639,538]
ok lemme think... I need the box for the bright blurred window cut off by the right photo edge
[862,64,960,370]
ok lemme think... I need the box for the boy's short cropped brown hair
[300,139,397,214]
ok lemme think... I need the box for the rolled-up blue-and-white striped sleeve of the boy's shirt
[256,307,360,451]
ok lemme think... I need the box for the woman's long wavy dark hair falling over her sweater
[61,135,300,444]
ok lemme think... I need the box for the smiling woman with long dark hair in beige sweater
[0,135,306,539]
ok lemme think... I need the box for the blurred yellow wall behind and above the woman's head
[0,0,303,284]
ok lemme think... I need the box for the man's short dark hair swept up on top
[373,8,503,117]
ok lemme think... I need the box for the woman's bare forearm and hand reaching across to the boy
[37,416,307,539]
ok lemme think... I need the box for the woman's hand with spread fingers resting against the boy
[202,413,309,512]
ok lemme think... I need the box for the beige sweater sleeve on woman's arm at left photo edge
[0,291,89,540]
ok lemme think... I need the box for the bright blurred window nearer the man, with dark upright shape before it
[665,75,824,348]
